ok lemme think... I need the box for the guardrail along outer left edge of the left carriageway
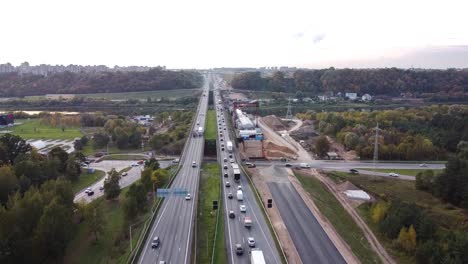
[127,83,208,264]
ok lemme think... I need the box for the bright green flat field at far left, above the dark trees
[6,119,82,139]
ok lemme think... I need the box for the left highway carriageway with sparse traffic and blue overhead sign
[138,76,209,264]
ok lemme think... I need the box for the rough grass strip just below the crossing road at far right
[348,175,468,230]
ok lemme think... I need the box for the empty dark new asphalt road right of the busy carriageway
[268,182,346,264]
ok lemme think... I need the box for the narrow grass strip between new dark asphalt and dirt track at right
[296,173,381,263]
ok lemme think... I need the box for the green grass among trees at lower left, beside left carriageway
[63,187,149,264]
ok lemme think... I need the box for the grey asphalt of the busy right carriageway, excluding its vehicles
[214,77,281,264]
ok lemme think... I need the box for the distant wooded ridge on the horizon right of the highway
[231,68,468,99]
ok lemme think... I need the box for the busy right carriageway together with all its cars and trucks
[214,75,281,263]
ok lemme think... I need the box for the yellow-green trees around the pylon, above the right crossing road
[297,105,468,160]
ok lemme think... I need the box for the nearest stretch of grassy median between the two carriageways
[196,163,227,263]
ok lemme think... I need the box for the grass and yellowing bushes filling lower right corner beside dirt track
[328,144,468,263]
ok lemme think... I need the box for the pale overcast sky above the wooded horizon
[0,0,468,68]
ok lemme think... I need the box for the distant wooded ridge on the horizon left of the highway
[0,68,203,97]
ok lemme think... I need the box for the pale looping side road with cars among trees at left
[73,160,171,203]
